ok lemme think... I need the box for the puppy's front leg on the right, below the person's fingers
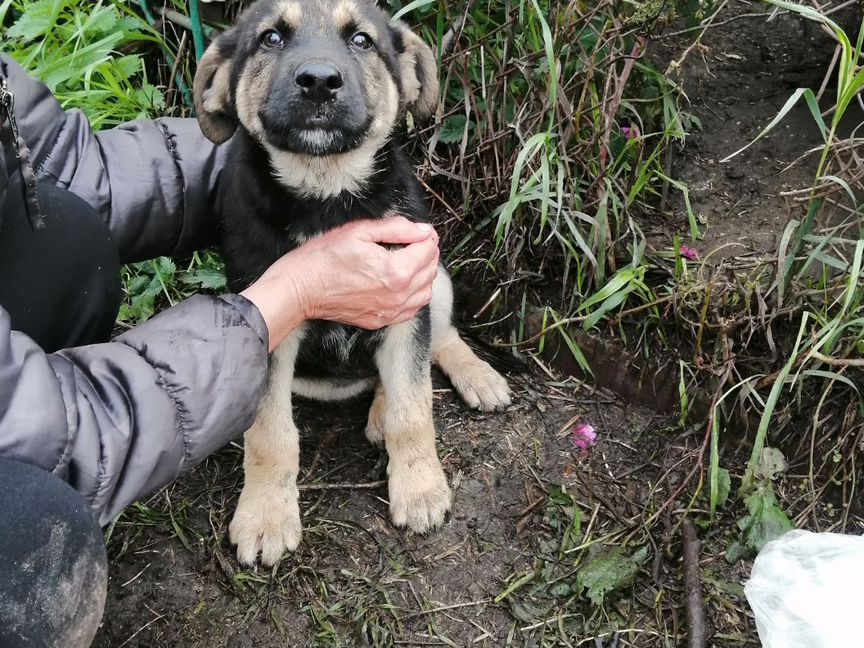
[375,309,451,533]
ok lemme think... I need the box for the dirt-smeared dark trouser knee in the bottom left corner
[0,459,108,648]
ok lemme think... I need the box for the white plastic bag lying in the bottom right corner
[744,530,864,648]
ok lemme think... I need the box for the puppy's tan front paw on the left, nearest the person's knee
[228,486,302,565]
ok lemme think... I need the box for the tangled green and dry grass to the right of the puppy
[398,0,864,568]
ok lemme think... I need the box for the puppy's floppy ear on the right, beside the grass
[390,20,439,119]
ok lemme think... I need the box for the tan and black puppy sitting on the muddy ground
[195,0,510,564]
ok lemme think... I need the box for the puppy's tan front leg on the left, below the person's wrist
[228,330,303,565]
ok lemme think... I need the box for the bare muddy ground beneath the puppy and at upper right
[95,5,864,648]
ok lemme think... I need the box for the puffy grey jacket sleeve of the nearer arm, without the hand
[0,295,267,524]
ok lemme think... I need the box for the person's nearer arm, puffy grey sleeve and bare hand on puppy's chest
[0,219,438,524]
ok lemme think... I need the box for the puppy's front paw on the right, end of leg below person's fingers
[388,456,452,533]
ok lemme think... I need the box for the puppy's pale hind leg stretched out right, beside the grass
[429,266,510,412]
